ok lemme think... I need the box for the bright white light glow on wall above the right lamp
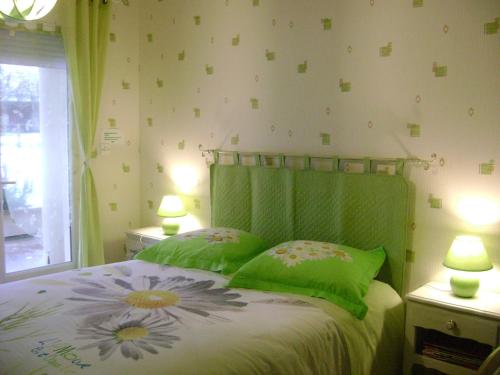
[457,196,500,226]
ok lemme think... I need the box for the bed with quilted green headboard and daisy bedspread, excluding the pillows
[0,160,408,374]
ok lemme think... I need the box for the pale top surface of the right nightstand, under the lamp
[406,282,500,320]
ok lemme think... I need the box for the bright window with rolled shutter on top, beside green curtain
[0,29,73,280]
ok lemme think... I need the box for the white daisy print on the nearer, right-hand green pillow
[268,241,352,267]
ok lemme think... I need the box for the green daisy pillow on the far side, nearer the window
[134,228,266,274]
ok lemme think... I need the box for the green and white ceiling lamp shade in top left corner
[0,0,57,21]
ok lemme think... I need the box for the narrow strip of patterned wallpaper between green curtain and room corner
[93,0,140,263]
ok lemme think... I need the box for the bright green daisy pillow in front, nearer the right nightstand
[228,241,385,319]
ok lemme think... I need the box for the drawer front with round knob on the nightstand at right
[409,302,499,347]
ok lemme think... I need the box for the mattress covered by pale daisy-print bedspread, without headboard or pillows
[0,260,403,375]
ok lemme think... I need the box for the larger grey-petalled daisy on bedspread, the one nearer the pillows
[68,266,246,325]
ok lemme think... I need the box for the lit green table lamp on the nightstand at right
[443,235,493,298]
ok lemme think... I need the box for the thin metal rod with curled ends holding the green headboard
[198,144,445,170]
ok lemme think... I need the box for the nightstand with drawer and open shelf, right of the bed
[404,283,500,375]
